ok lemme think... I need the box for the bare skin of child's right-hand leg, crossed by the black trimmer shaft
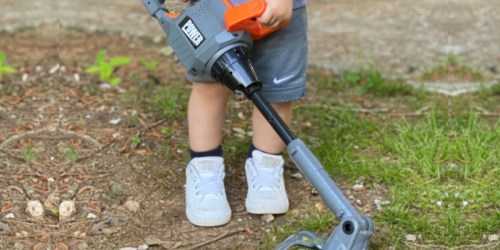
[252,102,292,154]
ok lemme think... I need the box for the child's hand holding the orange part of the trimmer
[257,0,293,28]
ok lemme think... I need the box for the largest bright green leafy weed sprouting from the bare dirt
[85,50,130,85]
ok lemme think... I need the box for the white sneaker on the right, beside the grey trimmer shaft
[245,150,288,214]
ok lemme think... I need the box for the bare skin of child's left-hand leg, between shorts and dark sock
[188,83,231,152]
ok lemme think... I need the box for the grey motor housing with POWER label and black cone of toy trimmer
[144,0,260,93]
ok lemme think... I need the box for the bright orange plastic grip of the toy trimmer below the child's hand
[223,0,288,40]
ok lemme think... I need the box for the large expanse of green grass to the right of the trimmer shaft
[272,100,500,247]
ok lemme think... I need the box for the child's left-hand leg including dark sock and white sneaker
[186,83,231,226]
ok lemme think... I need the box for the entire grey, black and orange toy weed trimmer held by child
[143,0,373,250]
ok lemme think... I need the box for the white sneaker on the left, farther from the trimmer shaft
[186,157,231,227]
